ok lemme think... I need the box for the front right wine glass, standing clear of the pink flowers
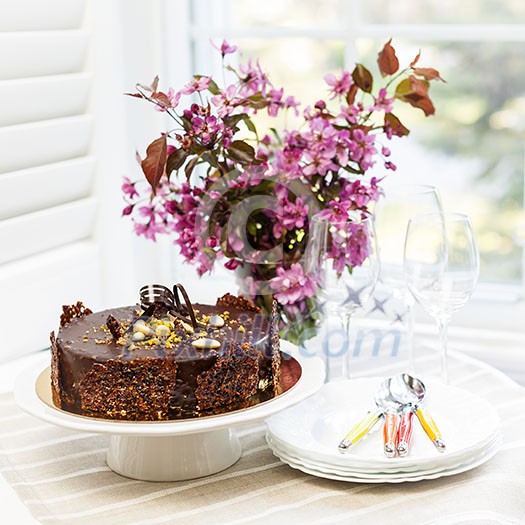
[404,213,479,384]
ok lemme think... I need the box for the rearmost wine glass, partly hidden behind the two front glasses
[375,184,443,371]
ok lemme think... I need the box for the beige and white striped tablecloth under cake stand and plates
[0,355,525,525]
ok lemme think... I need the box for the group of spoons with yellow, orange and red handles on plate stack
[338,373,446,458]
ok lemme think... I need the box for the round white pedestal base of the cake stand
[107,428,242,481]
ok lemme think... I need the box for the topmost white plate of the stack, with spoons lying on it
[267,378,499,472]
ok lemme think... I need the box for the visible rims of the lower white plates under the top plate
[270,438,502,483]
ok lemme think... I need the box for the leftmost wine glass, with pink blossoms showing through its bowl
[306,214,379,381]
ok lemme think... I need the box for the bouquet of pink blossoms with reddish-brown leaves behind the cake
[122,41,441,341]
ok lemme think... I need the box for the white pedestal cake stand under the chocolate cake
[14,341,324,481]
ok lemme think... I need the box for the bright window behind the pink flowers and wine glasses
[168,0,525,330]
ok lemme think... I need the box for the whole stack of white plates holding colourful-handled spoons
[266,378,502,483]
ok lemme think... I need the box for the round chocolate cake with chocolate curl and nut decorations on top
[51,285,281,421]
